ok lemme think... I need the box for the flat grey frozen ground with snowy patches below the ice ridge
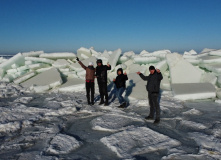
[0,84,221,160]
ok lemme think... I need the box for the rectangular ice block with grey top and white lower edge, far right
[171,83,216,100]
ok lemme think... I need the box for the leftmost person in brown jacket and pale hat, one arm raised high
[76,57,96,105]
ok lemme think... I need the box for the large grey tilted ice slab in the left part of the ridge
[21,68,63,88]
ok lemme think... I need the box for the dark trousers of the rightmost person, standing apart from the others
[148,93,160,119]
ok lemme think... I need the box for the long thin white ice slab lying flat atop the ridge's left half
[39,52,76,59]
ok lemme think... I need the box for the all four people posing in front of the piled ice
[76,58,163,123]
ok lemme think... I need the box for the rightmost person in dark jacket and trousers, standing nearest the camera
[137,66,163,123]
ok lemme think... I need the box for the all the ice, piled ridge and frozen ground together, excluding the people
[0,48,221,160]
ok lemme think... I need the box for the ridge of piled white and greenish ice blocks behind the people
[0,47,221,102]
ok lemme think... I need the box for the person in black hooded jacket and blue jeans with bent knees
[113,68,128,108]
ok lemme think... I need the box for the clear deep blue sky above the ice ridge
[0,0,221,54]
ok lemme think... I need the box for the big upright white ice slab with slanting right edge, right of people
[166,53,202,83]
